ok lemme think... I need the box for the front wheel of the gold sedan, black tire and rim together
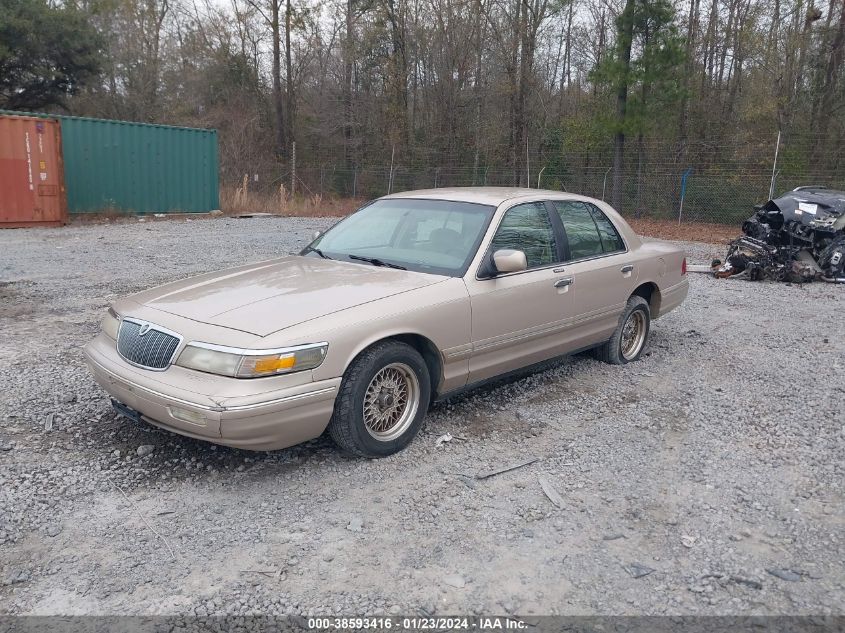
[329,341,431,457]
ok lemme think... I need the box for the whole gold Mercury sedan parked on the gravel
[85,187,688,457]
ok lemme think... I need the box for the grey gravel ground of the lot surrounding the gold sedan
[0,218,845,615]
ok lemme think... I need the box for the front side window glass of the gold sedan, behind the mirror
[490,202,557,268]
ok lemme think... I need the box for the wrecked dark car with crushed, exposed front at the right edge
[713,186,845,283]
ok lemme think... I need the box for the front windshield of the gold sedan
[302,198,495,277]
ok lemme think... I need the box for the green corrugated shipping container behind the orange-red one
[0,112,220,213]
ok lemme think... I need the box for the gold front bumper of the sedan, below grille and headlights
[83,333,341,451]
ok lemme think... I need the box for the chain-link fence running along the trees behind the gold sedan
[222,137,845,225]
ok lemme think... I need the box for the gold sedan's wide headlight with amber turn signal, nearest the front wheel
[176,342,329,378]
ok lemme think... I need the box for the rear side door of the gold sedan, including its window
[550,200,638,346]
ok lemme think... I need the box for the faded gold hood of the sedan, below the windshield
[132,256,444,336]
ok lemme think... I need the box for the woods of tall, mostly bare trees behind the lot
[0,0,845,222]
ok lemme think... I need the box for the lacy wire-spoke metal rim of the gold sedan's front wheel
[364,363,420,442]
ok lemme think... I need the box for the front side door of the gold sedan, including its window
[465,202,574,383]
